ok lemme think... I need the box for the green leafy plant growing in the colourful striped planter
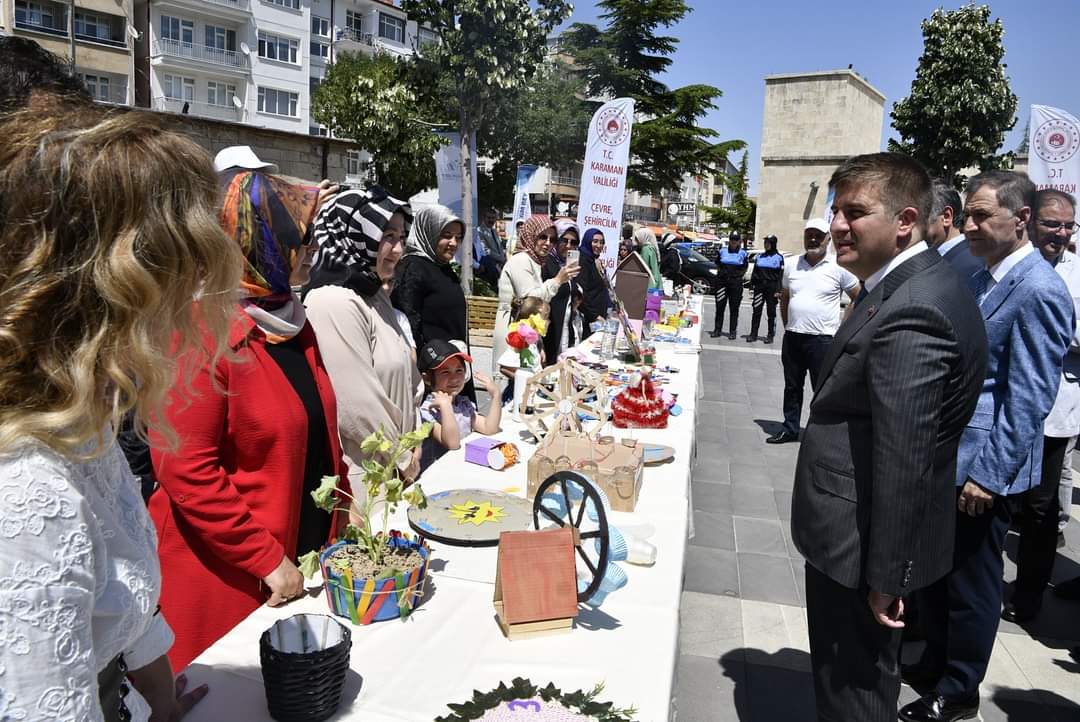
[299,423,431,576]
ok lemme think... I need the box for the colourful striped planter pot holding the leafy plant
[319,536,431,624]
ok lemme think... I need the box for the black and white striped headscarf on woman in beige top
[307,186,413,296]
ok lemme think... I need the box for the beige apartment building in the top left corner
[0,0,137,105]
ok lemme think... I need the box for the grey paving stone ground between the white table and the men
[673,295,1080,722]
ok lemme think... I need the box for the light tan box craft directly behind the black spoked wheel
[527,432,645,512]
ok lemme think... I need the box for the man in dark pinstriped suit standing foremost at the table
[792,153,986,722]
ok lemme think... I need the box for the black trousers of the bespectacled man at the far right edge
[1012,436,1069,612]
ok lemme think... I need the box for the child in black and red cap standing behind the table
[417,339,502,473]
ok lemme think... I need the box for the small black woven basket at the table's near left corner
[259,614,352,722]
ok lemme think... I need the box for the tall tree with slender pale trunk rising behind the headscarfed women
[402,0,571,292]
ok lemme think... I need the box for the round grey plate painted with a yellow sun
[408,489,532,546]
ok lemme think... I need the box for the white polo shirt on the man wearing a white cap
[784,254,859,336]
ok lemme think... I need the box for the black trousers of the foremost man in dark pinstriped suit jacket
[806,563,900,722]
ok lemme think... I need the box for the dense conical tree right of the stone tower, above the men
[889,3,1016,186]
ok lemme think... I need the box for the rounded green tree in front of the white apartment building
[311,53,445,197]
